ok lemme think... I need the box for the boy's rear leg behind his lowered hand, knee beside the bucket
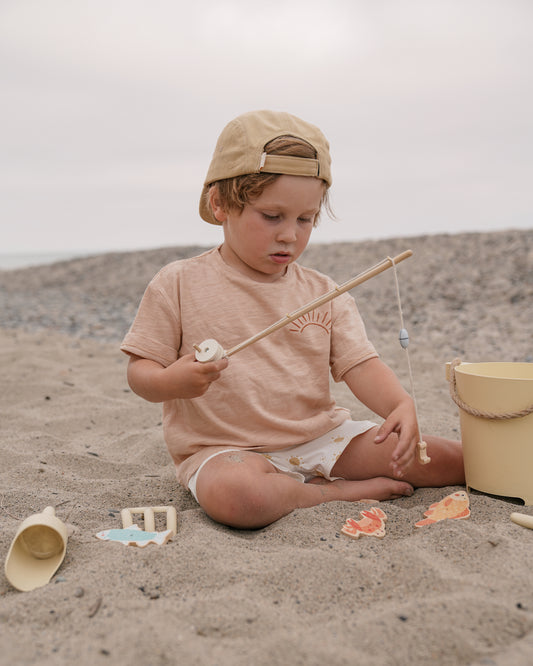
[331,428,465,488]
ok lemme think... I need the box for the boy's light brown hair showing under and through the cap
[206,136,334,225]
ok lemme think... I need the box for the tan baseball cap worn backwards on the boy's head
[200,111,331,224]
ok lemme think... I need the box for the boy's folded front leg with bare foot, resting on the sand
[196,451,413,529]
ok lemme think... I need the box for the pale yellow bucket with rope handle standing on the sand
[446,362,533,505]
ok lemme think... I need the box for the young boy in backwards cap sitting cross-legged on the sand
[121,111,464,528]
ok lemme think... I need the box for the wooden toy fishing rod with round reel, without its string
[194,250,413,363]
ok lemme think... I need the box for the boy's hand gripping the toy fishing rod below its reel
[165,354,229,398]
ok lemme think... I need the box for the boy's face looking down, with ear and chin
[212,175,324,282]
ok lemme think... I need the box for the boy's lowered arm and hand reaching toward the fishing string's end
[343,358,420,476]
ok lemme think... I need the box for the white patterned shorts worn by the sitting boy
[189,419,376,501]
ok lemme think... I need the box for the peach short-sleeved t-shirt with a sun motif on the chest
[121,248,377,487]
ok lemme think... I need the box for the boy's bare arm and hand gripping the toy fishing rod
[128,354,228,402]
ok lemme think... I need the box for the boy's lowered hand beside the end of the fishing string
[375,399,420,477]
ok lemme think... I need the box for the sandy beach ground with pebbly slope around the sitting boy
[0,231,533,666]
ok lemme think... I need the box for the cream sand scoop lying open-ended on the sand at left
[5,506,67,592]
